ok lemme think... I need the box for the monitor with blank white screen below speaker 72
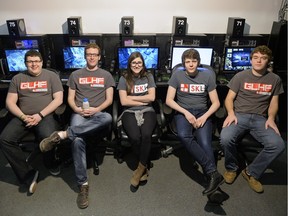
[171,46,213,69]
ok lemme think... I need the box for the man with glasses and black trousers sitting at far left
[0,50,63,194]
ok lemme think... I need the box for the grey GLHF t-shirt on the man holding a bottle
[67,68,115,107]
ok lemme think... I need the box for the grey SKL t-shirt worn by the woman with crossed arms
[117,73,156,110]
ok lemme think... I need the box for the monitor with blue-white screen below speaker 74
[63,46,86,69]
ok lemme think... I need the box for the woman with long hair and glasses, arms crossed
[117,52,156,192]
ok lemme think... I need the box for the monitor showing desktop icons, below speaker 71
[223,47,254,73]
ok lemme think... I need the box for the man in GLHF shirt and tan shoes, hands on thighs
[220,46,285,193]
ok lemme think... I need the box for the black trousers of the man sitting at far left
[0,114,59,183]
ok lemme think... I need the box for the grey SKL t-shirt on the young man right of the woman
[168,70,216,109]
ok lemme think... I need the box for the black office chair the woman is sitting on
[112,100,166,166]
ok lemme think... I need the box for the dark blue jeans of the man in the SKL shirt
[174,109,216,174]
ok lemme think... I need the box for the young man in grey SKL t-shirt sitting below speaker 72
[166,49,224,195]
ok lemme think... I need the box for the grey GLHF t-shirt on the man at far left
[8,69,63,115]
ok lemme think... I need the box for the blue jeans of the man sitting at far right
[220,113,285,179]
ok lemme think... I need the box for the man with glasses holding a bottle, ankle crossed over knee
[40,43,115,209]
